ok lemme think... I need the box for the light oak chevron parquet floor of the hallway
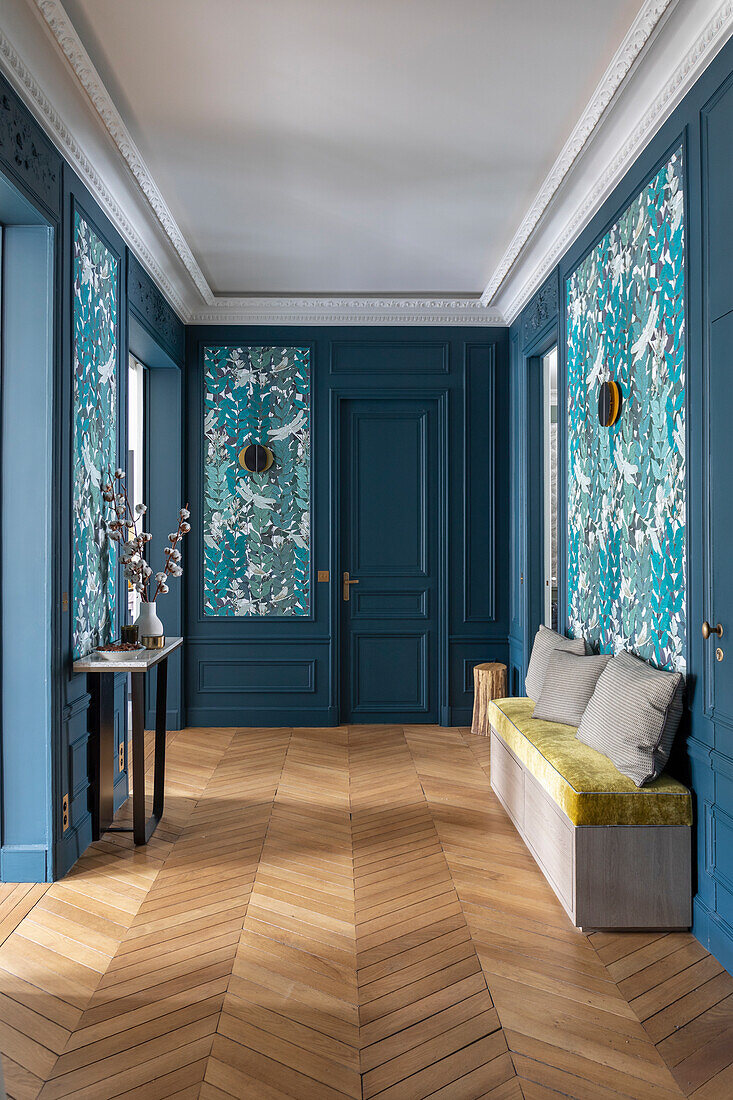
[0,726,733,1100]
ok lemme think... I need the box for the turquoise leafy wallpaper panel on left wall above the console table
[72,210,119,659]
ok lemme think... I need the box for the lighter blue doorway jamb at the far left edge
[0,226,54,880]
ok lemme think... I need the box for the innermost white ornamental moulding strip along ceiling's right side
[482,0,677,305]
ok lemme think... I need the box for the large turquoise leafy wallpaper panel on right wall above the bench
[567,149,687,672]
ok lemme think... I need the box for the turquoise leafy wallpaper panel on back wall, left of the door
[203,347,310,617]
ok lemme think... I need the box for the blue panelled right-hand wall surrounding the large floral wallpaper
[508,44,733,970]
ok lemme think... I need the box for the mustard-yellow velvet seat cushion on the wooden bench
[489,699,692,825]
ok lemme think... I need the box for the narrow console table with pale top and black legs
[74,638,183,844]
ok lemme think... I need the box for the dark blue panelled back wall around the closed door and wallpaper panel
[184,326,508,726]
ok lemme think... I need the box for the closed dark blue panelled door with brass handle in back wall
[335,396,439,723]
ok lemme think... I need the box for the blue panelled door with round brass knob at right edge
[688,78,733,972]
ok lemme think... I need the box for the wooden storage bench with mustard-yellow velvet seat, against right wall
[489,699,692,930]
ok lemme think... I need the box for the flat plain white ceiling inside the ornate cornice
[57,0,641,295]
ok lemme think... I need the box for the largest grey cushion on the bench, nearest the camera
[578,653,685,787]
